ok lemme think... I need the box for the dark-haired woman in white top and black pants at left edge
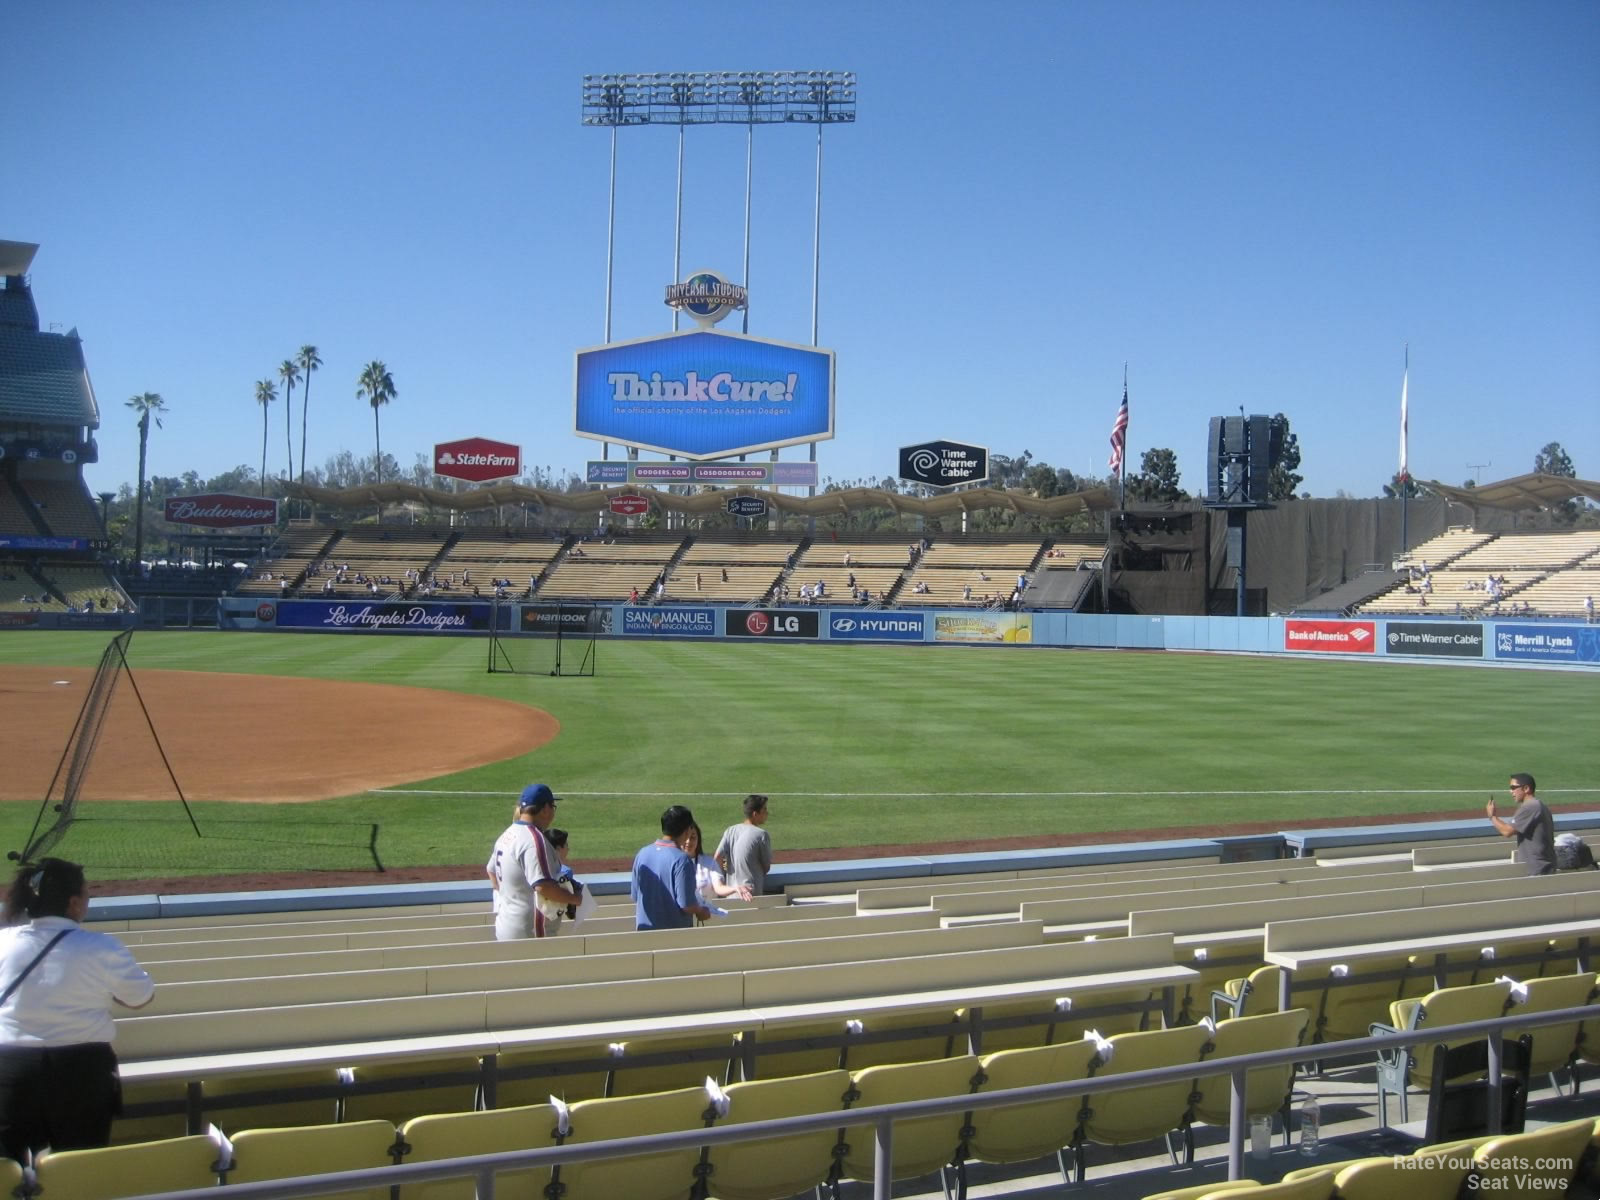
[0,858,155,1162]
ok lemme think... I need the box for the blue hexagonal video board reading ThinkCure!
[574,330,834,459]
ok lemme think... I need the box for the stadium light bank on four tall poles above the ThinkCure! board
[582,70,856,345]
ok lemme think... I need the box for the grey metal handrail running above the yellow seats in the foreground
[112,1005,1600,1200]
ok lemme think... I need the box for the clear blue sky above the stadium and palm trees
[0,0,1600,496]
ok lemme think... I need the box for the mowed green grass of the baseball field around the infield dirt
[0,632,1600,877]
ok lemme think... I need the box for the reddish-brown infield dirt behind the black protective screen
[0,667,560,803]
